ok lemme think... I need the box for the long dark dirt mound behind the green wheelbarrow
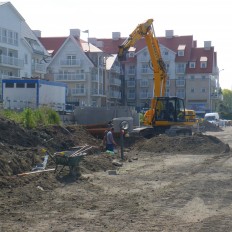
[0,118,116,176]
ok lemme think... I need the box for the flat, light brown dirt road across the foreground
[0,127,232,232]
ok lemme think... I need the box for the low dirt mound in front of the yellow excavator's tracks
[135,134,229,154]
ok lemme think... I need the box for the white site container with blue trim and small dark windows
[3,79,66,110]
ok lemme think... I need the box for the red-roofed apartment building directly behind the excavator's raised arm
[94,30,221,114]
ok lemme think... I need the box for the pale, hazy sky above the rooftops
[10,0,232,89]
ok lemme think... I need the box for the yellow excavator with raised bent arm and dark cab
[118,19,196,138]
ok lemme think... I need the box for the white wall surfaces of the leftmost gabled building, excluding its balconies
[0,2,49,78]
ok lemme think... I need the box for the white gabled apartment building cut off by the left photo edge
[0,2,49,100]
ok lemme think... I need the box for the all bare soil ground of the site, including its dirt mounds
[0,118,232,232]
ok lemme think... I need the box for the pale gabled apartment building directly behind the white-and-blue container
[38,29,122,107]
